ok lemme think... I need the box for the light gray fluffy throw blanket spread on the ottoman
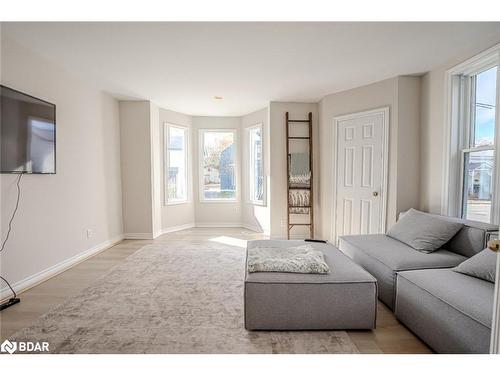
[247,245,330,274]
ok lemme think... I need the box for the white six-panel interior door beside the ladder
[333,108,388,241]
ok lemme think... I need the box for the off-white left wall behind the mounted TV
[0,36,123,288]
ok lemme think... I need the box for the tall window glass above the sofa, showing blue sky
[461,66,497,223]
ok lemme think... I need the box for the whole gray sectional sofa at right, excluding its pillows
[339,215,498,353]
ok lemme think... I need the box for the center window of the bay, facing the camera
[200,130,237,201]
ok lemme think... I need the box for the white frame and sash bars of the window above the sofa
[441,44,500,224]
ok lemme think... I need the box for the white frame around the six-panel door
[331,106,389,244]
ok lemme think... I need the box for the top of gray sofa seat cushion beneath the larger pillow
[342,234,467,271]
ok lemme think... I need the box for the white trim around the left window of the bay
[163,122,191,206]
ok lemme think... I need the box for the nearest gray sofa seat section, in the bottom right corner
[395,269,494,353]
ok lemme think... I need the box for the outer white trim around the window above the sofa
[441,44,500,223]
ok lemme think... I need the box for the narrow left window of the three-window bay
[165,124,188,204]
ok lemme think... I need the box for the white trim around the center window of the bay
[198,128,240,203]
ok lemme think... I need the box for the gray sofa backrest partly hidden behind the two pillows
[399,211,498,258]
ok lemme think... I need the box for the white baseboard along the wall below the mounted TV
[0,235,123,300]
